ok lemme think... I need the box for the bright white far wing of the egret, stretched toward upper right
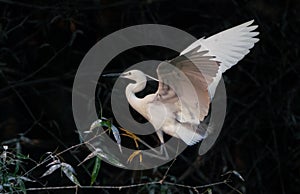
[180,20,259,98]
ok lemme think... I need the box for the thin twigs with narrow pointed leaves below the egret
[0,118,244,194]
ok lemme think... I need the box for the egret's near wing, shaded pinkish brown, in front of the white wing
[157,47,219,123]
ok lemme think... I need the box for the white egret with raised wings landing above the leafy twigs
[121,20,259,152]
